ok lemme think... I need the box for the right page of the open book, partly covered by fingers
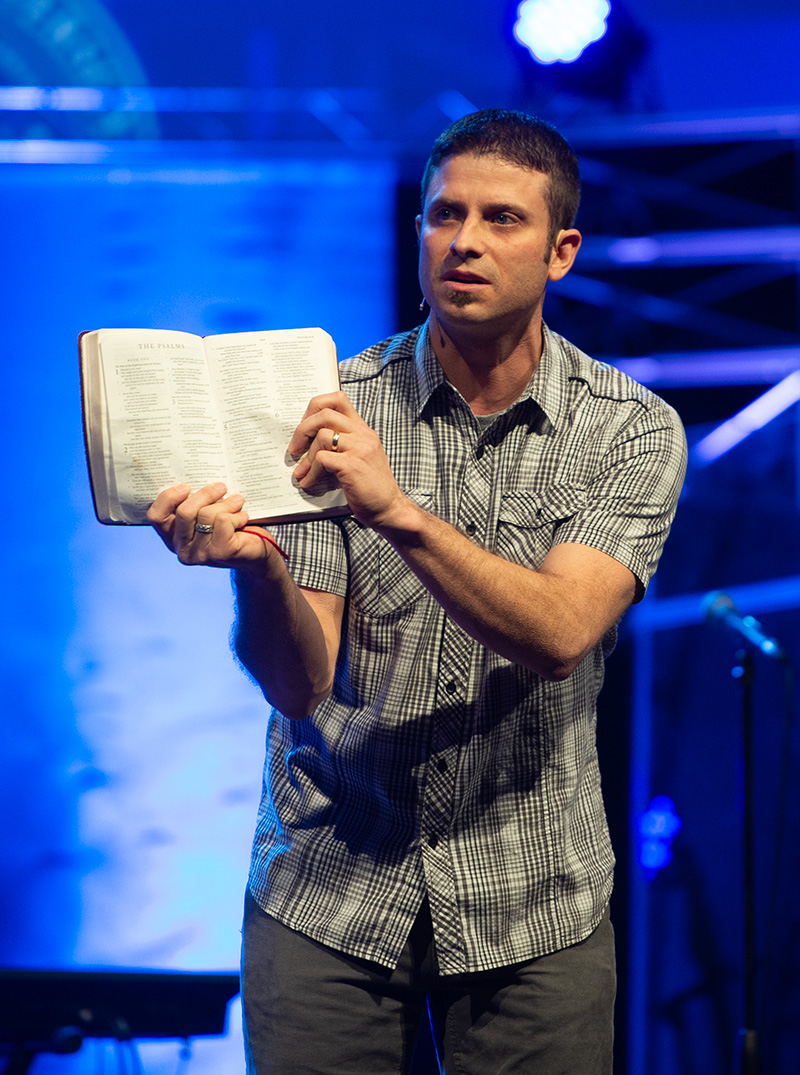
[205,329,345,518]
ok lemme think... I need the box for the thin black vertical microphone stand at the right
[731,649,759,1075]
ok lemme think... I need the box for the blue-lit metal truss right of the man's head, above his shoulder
[559,113,800,374]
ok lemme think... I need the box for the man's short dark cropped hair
[423,109,581,242]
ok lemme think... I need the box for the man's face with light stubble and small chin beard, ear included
[416,154,580,332]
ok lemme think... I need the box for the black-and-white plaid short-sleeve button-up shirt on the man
[249,318,685,974]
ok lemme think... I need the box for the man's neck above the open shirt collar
[429,313,543,414]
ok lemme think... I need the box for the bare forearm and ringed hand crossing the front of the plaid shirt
[289,392,637,679]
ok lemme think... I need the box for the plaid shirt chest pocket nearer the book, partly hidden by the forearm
[346,489,433,617]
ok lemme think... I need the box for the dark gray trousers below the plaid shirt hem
[242,894,616,1075]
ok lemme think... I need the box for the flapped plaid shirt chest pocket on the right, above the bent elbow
[496,484,587,568]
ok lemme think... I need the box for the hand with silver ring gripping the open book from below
[147,482,281,573]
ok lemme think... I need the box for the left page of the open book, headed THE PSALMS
[99,329,227,522]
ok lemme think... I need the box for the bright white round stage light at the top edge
[514,0,611,63]
